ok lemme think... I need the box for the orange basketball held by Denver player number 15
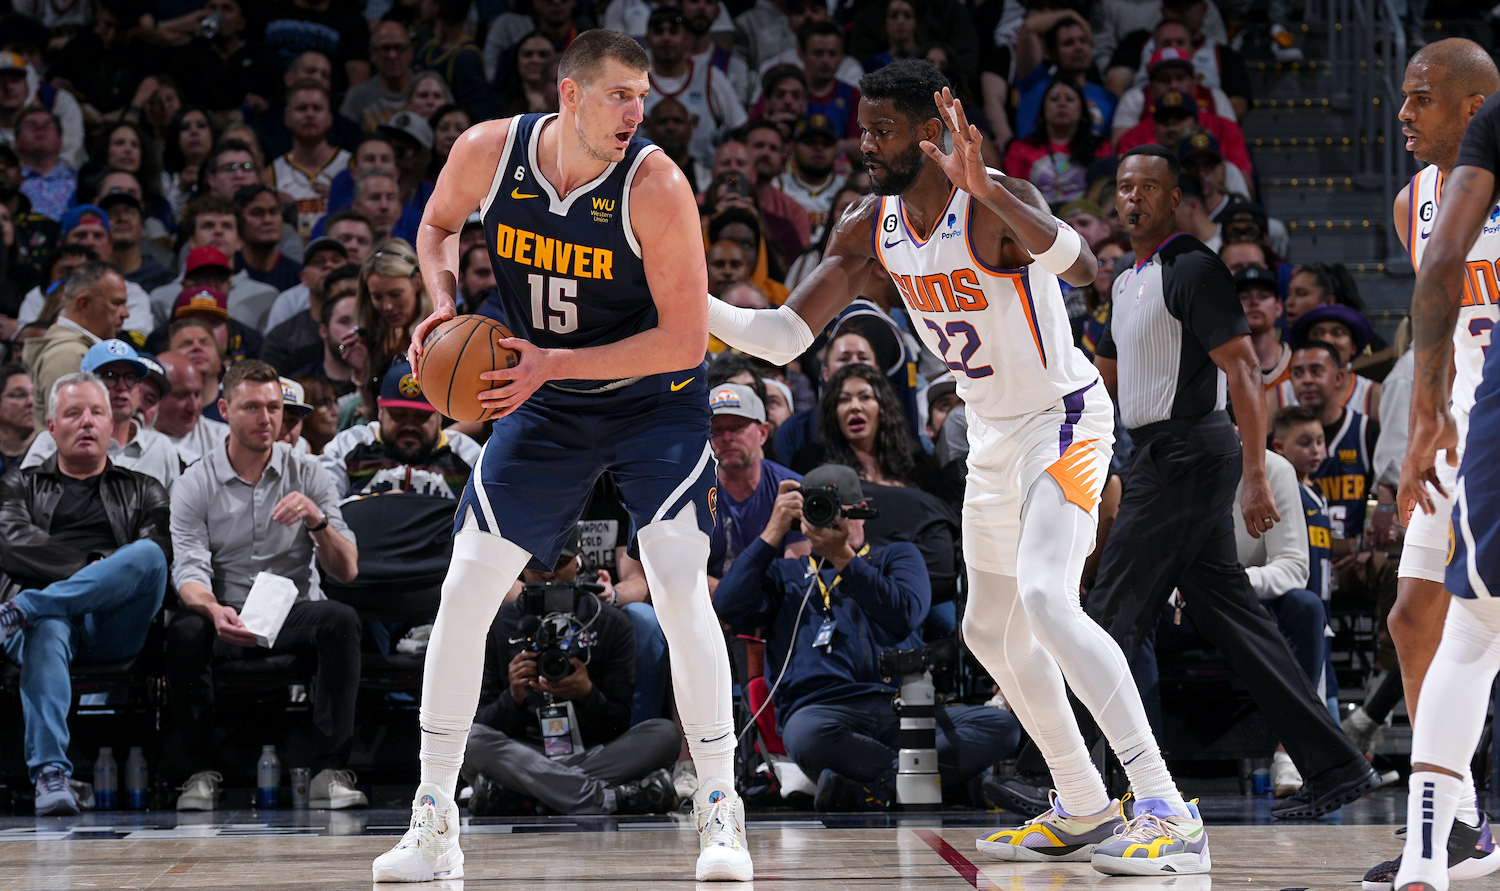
[417,315,521,422]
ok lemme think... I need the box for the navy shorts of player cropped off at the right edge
[1437,376,1500,599]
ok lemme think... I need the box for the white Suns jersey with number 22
[873,189,1100,419]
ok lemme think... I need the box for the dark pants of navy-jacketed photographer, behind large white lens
[782,693,1020,789]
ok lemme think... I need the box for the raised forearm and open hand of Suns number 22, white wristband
[921,87,1098,288]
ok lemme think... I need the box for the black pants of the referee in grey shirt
[1085,411,1359,779]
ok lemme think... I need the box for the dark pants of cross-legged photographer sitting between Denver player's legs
[464,714,683,813]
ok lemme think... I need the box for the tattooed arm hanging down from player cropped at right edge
[1397,165,1496,515]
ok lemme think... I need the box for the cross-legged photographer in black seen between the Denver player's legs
[464,531,683,816]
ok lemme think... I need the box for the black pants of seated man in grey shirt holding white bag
[167,600,360,776]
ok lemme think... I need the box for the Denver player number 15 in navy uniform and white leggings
[374,30,753,882]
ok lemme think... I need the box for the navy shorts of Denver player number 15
[455,368,717,572]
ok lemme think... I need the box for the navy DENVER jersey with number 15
[480,114,657,395]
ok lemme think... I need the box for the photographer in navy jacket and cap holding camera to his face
[714,464,1020,810]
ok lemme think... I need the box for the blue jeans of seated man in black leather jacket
[5,542,167,782]
